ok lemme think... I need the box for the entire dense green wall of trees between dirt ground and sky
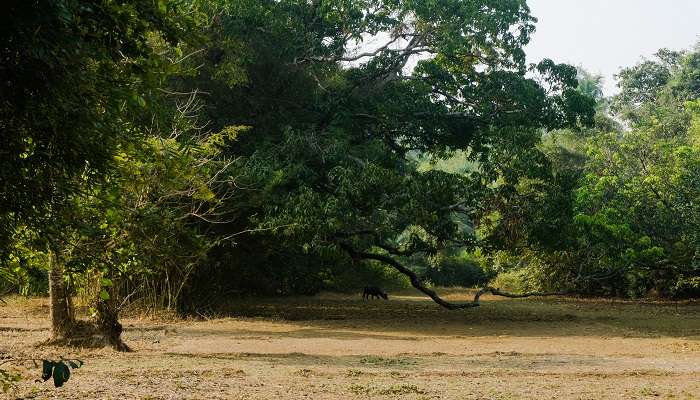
[0,0,700,348]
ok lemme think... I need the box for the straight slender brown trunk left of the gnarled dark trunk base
[49,250,73,340]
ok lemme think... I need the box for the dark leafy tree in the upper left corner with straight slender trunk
[0,0,197,337]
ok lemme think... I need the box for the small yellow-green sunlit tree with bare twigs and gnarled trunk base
[38,94,238,350]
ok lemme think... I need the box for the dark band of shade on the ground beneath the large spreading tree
[171,292,700,340]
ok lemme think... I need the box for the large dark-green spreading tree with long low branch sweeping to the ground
[178,0,594,308]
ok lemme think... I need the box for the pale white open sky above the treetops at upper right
[526,0,700,95]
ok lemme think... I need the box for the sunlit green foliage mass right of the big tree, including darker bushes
[490,50,700,297]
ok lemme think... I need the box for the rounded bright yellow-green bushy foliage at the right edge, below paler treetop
[576,128,700,296]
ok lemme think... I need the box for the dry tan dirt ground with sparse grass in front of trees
[0,290,700,400]
